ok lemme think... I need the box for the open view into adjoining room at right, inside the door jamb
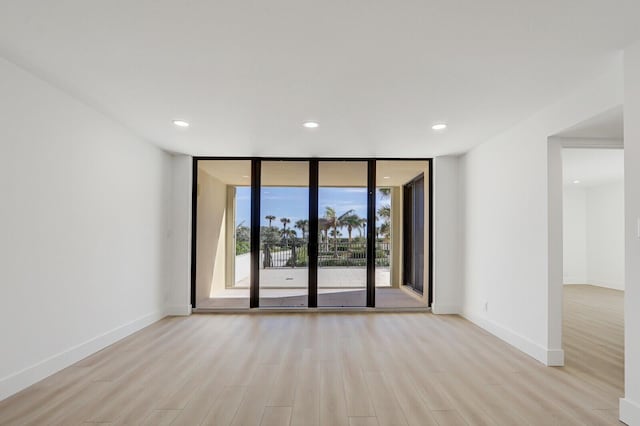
[562,148,625,397]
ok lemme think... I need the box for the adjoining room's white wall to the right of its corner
[586,182,624,290]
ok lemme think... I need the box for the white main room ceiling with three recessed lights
[0,0,640,157]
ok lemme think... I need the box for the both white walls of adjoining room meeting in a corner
[563,181,624,290]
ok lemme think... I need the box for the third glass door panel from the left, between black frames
[318,161,368,307]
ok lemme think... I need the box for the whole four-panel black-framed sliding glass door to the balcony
[191,157,431,310]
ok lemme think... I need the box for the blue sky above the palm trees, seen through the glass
[236,186,389,233]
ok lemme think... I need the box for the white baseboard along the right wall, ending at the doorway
[461,312,564,367]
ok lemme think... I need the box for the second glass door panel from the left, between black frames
[259,161,309,307]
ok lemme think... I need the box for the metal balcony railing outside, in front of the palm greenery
[260,238,391,268]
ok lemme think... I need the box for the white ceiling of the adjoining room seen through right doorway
[562,149,624,187]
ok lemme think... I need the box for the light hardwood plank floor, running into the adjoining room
[0,288,622,426]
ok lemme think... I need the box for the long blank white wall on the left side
[0,59,171,399]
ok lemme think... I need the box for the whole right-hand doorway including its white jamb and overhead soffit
[546,106,625,408]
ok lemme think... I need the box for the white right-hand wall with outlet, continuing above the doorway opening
[460,58,622,365]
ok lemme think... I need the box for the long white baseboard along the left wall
[0,312,165,401]
